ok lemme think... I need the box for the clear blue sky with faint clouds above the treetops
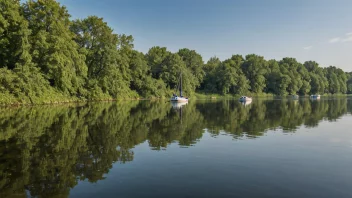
[59,0,352,71]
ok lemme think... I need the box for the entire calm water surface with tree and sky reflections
[0,98,352,198]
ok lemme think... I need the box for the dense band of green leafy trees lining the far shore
[0,0,352,106]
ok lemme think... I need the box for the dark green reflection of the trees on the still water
[0,98,352,197]
